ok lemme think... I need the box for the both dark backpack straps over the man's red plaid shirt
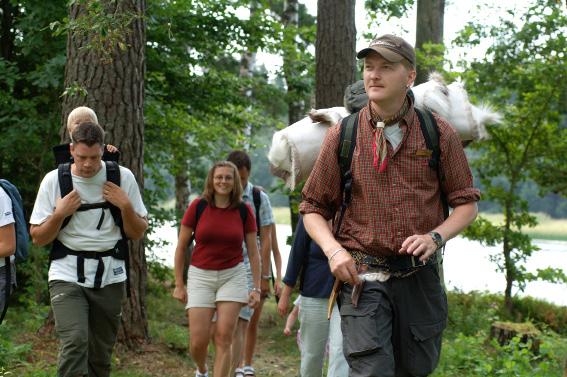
[335,106,449,236]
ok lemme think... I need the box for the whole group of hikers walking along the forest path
[0,35,480,377]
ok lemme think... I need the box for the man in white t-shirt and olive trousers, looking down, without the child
[30,123,148,377]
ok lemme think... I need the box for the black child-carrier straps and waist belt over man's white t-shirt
[49,161,130,297]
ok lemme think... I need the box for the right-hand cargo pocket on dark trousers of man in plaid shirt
[409,320,447,376]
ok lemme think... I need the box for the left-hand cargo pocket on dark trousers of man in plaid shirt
[340,302,382,357]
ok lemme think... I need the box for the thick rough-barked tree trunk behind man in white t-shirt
[61,0,148,347]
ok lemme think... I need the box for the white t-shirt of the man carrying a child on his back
[30,163,148,288]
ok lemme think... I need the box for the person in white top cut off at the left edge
[0,187,16,315]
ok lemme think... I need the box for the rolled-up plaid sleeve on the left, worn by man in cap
[299,123,342,220]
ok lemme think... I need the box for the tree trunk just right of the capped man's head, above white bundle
[415,0,445,85]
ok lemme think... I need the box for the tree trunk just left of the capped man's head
[315,0,356,109]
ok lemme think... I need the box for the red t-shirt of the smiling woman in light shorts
[181,198,256,270]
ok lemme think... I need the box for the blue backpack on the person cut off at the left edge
[0,179,30,324]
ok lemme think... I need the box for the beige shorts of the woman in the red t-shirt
[185,263,248,309]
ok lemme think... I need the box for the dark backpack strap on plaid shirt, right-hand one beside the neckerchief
[414,108,449,218]
